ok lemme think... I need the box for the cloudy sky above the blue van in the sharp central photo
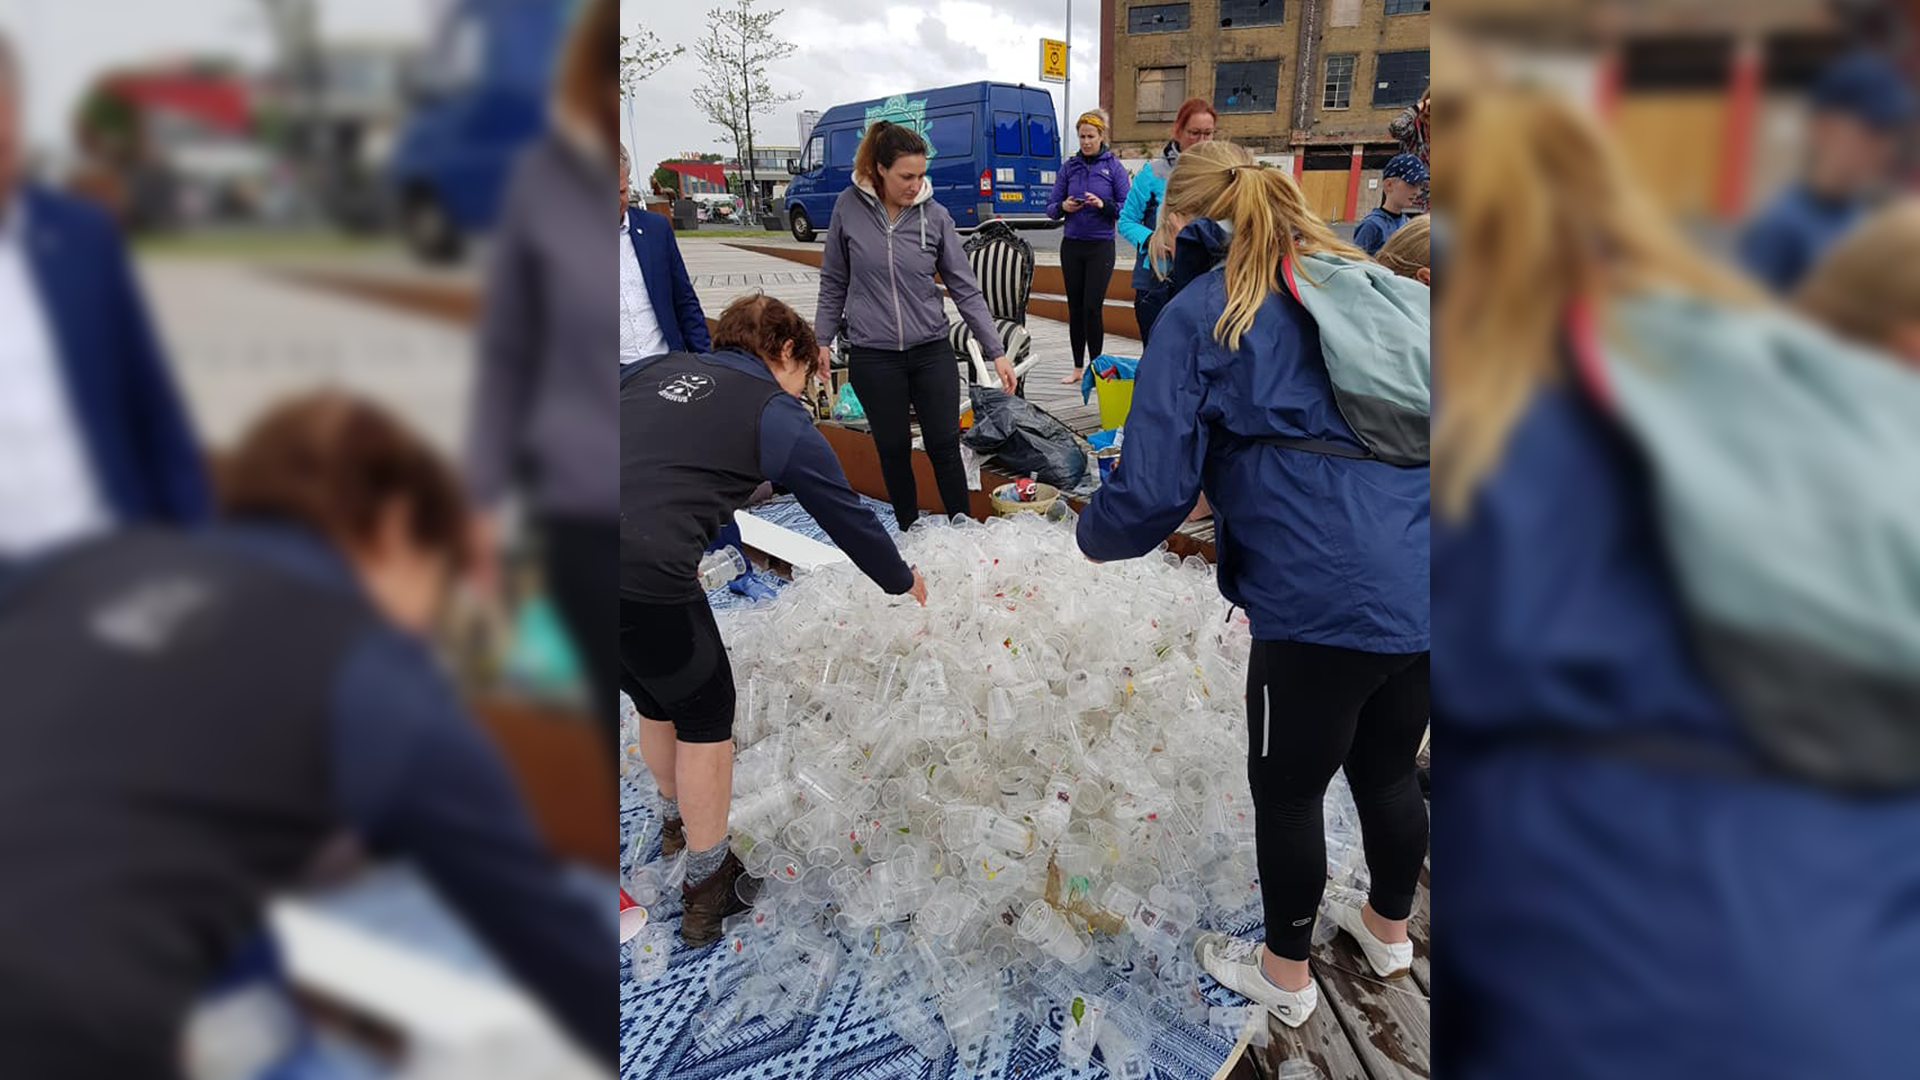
[620,0,1100,165]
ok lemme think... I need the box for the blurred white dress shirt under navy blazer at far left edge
[0,194,111,561]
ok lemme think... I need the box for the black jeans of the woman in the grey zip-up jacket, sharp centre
[847,338,968,530]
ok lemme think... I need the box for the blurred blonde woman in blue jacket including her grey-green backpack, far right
[1432,90,1920,1080]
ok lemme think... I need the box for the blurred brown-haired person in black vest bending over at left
[0,392,618,1080]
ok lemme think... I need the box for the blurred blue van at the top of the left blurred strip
[386,0,578,261]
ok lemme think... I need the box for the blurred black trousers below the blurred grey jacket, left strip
[540,513,620,764]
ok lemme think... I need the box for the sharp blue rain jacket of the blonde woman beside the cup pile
[1077,269,1428,653]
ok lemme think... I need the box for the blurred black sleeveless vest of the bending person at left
[0,532,378,1080]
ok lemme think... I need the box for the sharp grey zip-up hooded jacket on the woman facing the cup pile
[814,177,1004,361]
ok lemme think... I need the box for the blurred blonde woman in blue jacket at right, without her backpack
[1443,92,1920,1080]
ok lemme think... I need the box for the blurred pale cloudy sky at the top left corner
[0,0,432,152]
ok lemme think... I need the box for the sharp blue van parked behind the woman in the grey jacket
[785,83,1060,240]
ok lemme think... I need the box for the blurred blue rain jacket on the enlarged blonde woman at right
[1436,376,1920,1080]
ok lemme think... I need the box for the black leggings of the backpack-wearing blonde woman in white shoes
[1246,642,1428,961]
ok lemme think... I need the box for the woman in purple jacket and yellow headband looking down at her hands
[1046,110,1127,384]
